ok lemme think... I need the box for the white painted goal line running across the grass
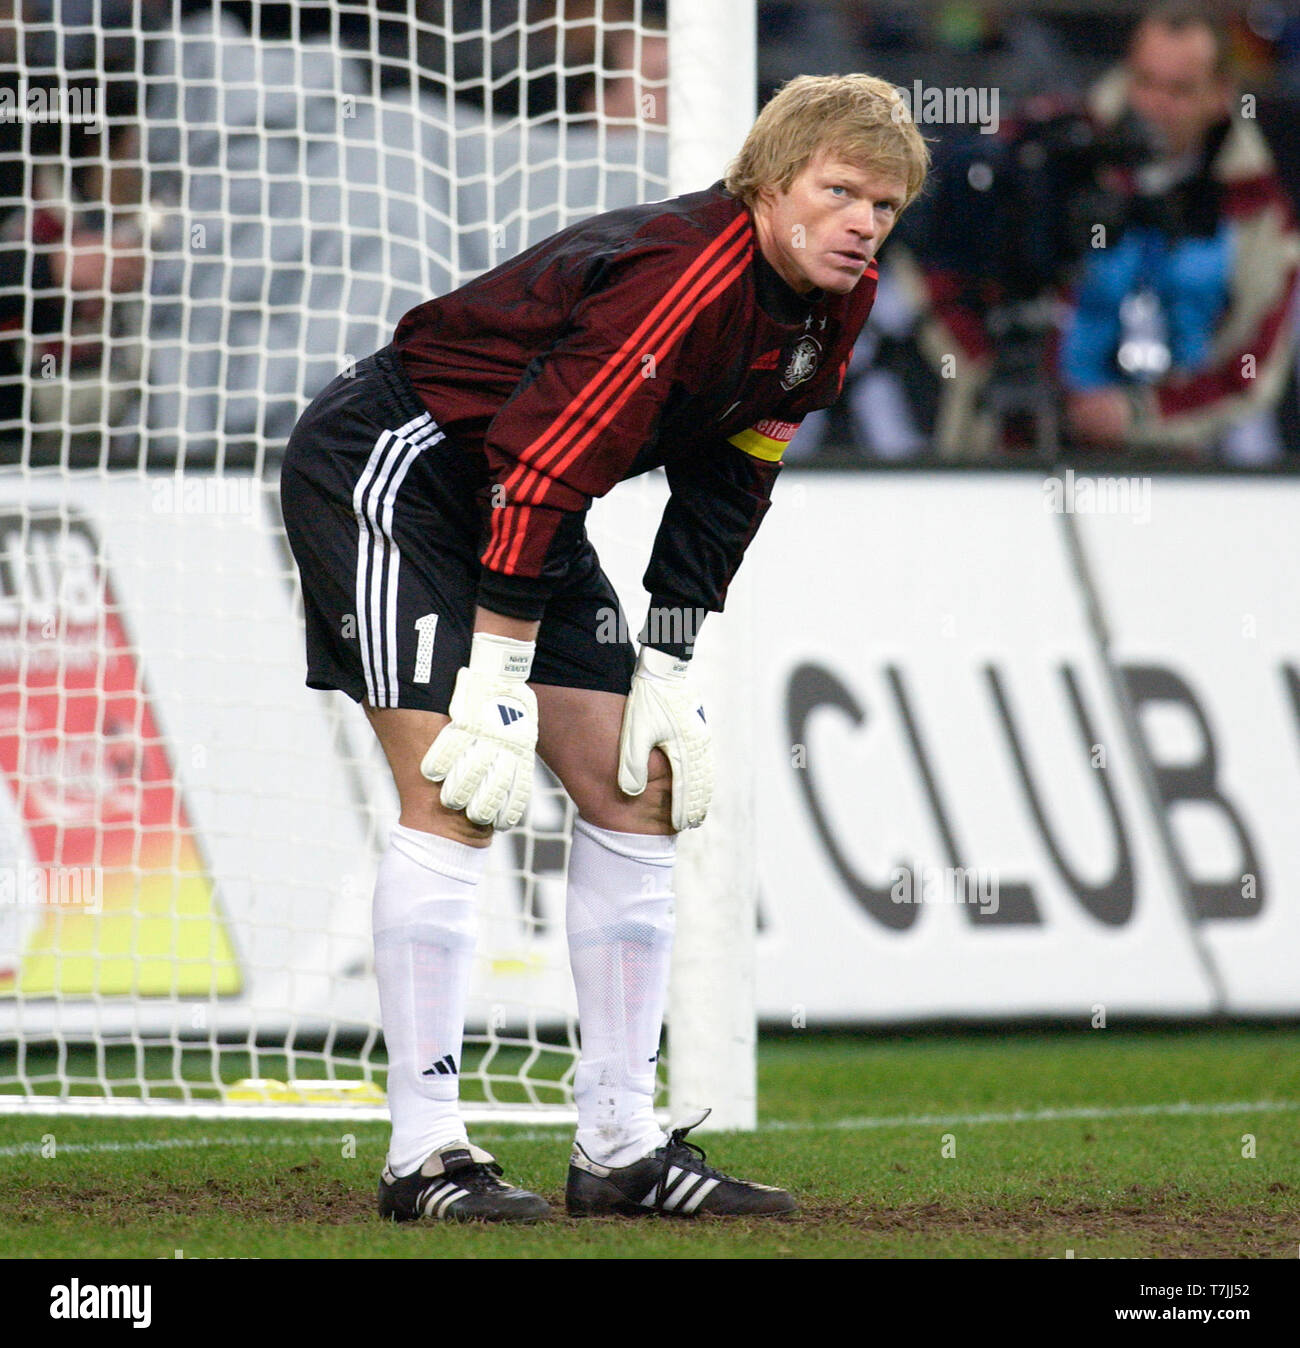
[0,1100,1300,1159]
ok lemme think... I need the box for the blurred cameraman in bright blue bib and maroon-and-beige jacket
[1060,3,1300,458]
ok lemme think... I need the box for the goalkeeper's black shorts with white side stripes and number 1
[280,348,635,714]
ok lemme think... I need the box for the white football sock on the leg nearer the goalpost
[566,818,677,1166]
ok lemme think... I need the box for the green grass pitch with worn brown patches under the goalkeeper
[0,1026,1300,1259]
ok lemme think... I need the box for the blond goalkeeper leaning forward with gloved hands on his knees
[282,74,929,1221]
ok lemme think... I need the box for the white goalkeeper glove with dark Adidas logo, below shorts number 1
[419,632,537,829]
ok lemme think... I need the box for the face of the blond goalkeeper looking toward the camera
[754,150,908,295]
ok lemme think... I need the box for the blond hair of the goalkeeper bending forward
[726,74,930,206]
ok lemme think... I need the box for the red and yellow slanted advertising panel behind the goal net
[0,511,241,999]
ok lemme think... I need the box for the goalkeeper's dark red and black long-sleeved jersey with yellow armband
[394,183,877,636]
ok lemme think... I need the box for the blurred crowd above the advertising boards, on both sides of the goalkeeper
[0,0,1300,468]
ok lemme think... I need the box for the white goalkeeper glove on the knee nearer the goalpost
[619,646,713,833]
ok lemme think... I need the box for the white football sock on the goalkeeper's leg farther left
[374,824,488,1175]
